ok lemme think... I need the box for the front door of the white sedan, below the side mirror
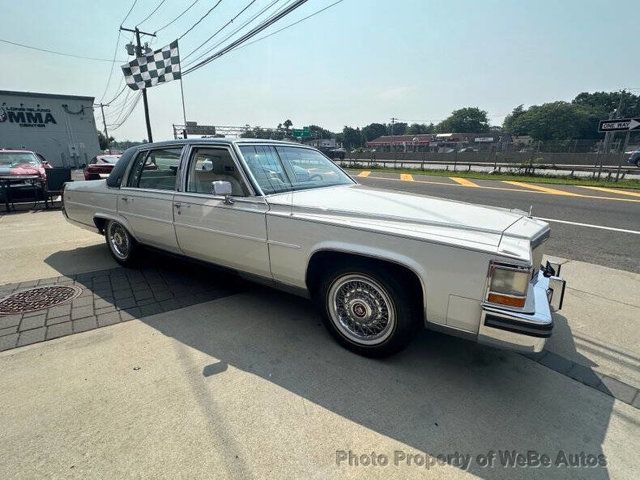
[174,145,271,278]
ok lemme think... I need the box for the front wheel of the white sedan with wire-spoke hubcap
[318,264,422,357]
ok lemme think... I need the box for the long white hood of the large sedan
[268,185,548,260]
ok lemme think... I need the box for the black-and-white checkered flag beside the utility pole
[122,40,180,90]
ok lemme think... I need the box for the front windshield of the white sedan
[240,145,354,195]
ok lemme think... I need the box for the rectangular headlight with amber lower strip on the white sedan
[487,262,531,308]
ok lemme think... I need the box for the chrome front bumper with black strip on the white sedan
[478,265,566,353]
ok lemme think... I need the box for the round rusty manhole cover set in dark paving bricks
[0,285,82,315]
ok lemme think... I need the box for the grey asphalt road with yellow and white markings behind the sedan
[350,170,640,273]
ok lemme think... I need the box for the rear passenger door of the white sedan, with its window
[118,146,182,252]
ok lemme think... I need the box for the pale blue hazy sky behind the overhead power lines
[0,0,640,141]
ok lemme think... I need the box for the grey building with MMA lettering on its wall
[0,90,100,167]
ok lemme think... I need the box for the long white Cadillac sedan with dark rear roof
[63,139,565,356]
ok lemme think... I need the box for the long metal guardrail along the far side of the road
[334,158,640,181]
